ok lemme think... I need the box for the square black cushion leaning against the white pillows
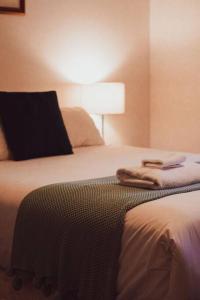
[0,91,73,160]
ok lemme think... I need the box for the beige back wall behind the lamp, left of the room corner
[0,0,149,146]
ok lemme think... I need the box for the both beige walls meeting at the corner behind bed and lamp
[0,0,200,152]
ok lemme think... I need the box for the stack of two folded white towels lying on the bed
[116,156,200,189]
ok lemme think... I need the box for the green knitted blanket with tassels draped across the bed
[11,177,200,300]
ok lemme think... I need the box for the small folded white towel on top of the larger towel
[142,153,186,170]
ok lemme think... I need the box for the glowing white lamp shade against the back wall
[81,82,125,115]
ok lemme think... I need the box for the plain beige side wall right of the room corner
[151,0,200,152]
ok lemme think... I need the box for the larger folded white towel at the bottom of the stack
[116,163,200,189]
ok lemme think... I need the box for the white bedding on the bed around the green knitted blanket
[0,146,200,300]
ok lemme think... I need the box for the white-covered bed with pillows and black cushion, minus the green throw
[0,91,200,300]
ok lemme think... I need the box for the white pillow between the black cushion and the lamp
[61,107,104,147]
